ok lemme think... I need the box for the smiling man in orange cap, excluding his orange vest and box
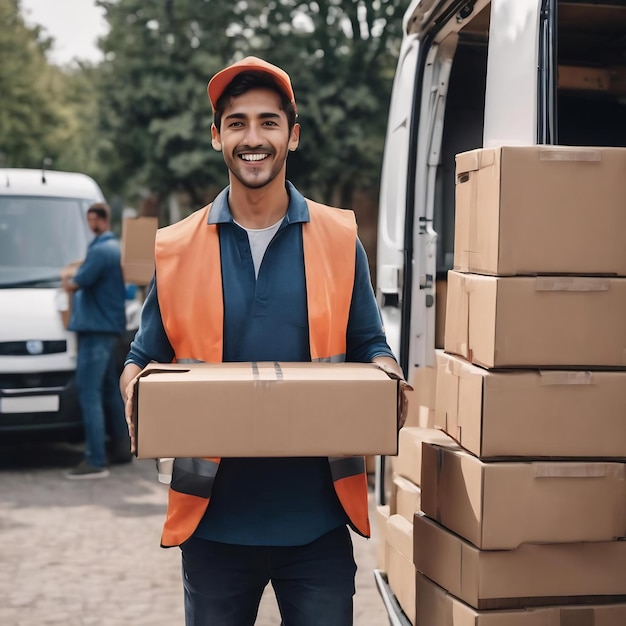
[120,58,406,626]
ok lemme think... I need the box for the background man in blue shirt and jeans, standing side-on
[63,202,132,479]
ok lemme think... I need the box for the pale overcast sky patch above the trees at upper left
[21,0,107,65]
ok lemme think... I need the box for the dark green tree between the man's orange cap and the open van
[244,0,406,206]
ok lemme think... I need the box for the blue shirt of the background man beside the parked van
[68,231,126,335]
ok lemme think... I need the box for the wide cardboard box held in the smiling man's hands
[132,363,398,459]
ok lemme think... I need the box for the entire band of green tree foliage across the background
[0,0,407,217]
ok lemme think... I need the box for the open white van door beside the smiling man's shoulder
[377,0,472,378]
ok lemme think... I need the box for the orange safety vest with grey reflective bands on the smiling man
[155,200,370,547]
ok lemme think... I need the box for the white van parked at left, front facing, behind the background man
[0,169,141,440]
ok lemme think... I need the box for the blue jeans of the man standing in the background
[76,333,128,467]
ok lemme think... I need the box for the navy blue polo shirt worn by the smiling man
[127,183,393,546]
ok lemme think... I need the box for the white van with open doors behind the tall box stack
[376,0,626,626]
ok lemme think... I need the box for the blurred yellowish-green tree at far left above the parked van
[0,0,103,173]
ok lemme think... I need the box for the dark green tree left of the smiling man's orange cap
[98,0,256,214]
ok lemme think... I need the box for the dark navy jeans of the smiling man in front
[181,526,356,626]
